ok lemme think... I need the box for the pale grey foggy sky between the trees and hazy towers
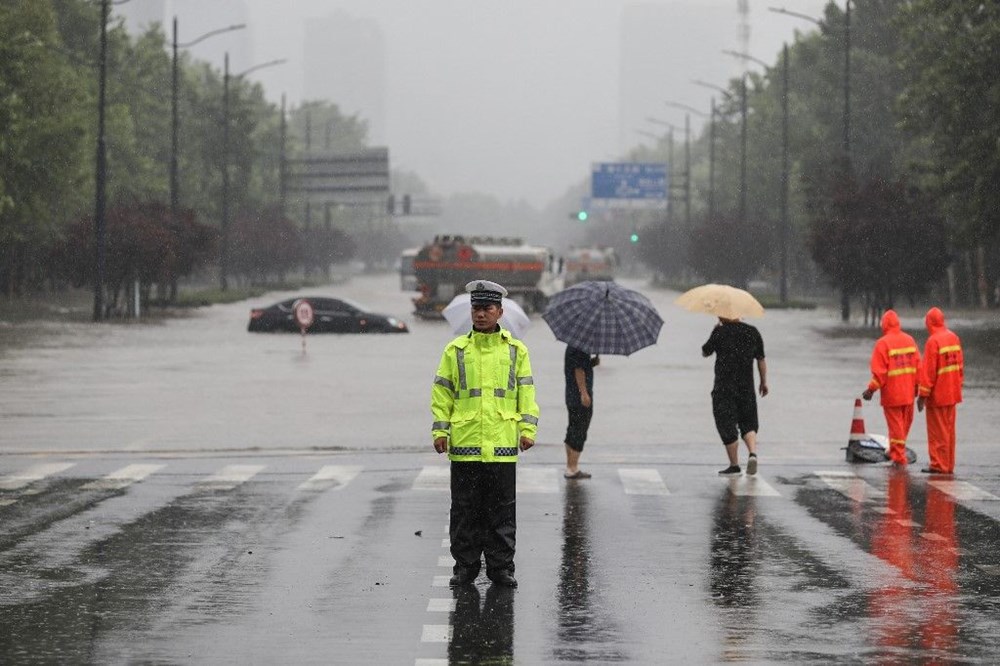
[178,0,826,207]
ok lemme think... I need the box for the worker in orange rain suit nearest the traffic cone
[861,310,920,465]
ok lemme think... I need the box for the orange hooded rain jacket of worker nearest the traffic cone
[868,310,920,407]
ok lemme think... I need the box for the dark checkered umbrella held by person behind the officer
[542,281,663,356]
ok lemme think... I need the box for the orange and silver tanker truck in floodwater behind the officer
[413,236,552,318]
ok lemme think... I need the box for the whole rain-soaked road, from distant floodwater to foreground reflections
[0,277,1000,664]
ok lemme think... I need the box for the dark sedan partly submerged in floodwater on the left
[247,296,409,333]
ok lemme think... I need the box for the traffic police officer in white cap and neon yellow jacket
[431,280,538,587]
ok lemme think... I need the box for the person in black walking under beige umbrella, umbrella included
[675,284,768,476]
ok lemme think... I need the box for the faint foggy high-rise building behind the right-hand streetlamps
[618,0,742,150]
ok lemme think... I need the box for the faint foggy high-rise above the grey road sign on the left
[302,12,386,145]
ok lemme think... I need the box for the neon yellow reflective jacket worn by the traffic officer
[431,329,538,462]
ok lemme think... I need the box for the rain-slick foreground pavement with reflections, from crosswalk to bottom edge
[0,451,1000,665]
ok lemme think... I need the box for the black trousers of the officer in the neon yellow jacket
[449,461,517,577]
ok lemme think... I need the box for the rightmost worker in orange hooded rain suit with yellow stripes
[917,308,965,474]
